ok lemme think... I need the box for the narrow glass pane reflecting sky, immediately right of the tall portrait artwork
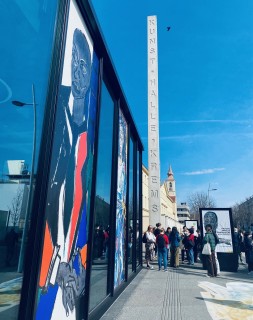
[89,83,114,310]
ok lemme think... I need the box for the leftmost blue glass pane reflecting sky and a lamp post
[0,0,57,319]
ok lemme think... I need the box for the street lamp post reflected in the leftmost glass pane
[12,84,36,272]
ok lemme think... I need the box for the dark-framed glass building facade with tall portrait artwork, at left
[0,0,143,320]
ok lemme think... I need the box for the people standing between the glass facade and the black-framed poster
[143,223,219,277]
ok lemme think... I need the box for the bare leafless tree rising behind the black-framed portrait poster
[188,192,216,220]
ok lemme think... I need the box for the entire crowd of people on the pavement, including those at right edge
[142,223,253,277]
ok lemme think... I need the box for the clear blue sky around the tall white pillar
[92,0,253,207]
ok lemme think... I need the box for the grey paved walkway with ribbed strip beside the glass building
[101,262,253,320]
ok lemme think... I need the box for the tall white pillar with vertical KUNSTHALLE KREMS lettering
[147,16,161,226]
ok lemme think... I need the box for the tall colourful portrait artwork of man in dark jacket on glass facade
[36,1,99,320]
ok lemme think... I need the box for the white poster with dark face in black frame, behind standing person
[199,208,233,253]
